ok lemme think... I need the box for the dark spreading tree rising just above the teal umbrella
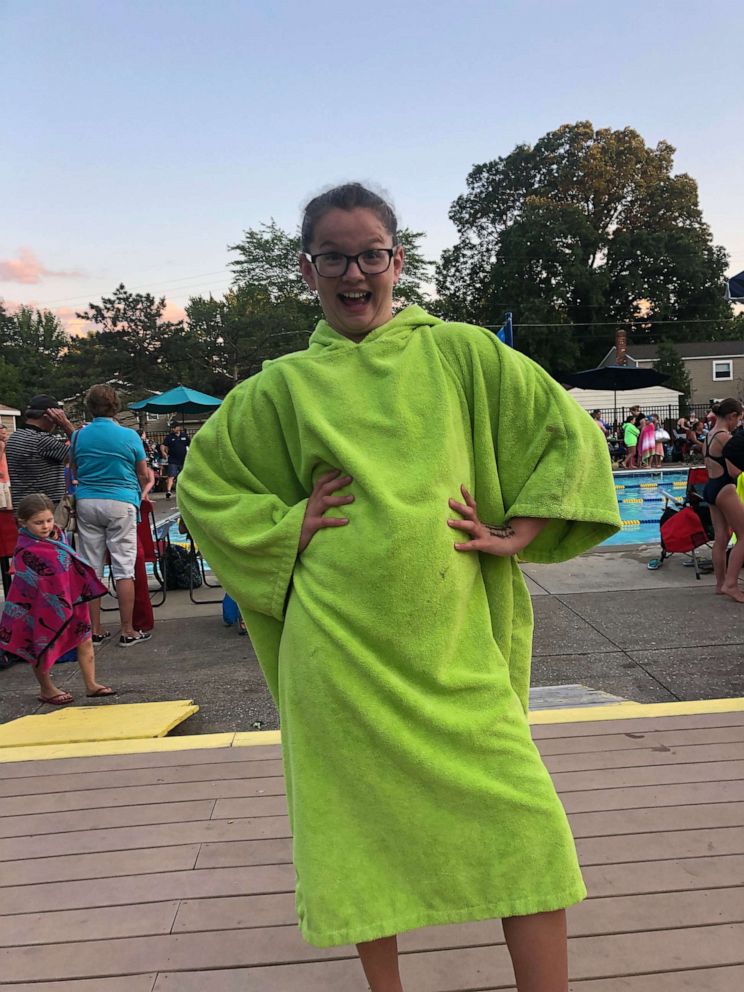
[77,283,183,392]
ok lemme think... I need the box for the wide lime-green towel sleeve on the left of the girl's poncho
[178,375,307,621]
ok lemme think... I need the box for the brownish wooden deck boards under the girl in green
[0,713,744,992]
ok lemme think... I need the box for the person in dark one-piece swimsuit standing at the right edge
[703,398,744,603]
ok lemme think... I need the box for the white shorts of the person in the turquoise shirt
[75,499,137,581]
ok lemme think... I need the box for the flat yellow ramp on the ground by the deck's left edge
[0,699,199,747]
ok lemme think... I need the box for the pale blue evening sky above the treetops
[0,0,744,334]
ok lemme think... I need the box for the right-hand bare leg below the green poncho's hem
[501,909,568,992]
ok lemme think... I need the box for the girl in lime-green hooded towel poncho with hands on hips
[179,184,619,992]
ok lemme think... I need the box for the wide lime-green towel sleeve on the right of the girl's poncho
[442,327,621,562]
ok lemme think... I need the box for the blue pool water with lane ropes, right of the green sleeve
[602,469,687,547]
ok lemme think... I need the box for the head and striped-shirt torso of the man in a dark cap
[5,393,75,507]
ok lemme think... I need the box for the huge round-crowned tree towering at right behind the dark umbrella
[437,121,731,374]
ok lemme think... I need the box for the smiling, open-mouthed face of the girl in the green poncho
[300,207,403,341]
